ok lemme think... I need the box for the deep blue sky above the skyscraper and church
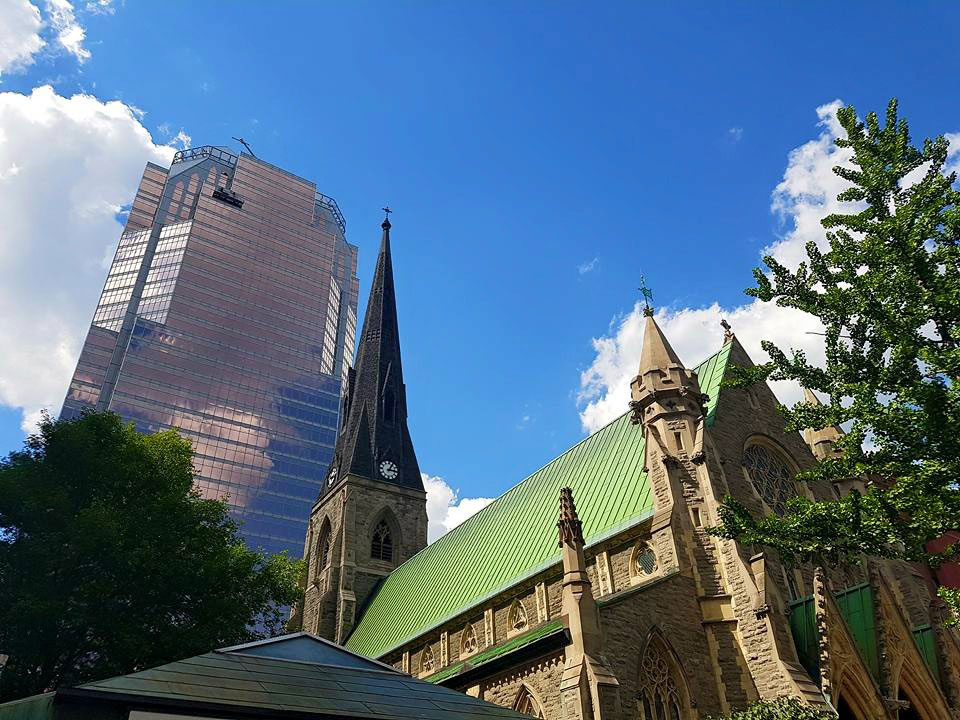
[0,0,960,528]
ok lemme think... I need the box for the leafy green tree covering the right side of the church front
[719,100,960,613]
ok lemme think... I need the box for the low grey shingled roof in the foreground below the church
[66,633,523,720]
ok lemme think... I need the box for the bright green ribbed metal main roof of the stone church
[346,343,730,657]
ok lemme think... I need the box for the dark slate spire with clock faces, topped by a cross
[324,216,423,492]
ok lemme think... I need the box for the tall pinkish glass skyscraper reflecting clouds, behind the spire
[61,146,357,557]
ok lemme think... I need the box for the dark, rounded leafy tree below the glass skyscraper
[0,413,302,701]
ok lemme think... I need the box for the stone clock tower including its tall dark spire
[294,212,427,643]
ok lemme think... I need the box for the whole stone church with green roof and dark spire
[293,220,960,720]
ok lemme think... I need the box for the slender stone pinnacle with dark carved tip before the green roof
[557,488,620,720]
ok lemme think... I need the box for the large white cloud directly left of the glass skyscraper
[0,86,174,430]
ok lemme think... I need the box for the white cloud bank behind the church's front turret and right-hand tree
[578,100,856,432]
